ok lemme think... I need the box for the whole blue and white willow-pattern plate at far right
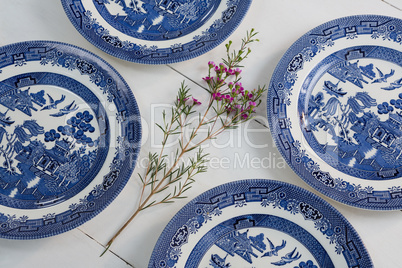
[268,15,402,210]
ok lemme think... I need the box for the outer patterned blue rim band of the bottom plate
[148,179,373,268]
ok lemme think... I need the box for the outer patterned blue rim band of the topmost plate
[61,0,252,64]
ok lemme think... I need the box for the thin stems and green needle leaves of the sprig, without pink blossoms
[101,29,265,256]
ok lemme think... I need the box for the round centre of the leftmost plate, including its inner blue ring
[0,73,109,209]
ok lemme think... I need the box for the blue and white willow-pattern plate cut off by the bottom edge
[148,179,373,268]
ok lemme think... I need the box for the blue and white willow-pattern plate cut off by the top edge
[61,0,252,64]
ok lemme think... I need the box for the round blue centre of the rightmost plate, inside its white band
[299,46,402,180]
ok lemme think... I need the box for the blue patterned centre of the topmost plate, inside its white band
[92,0,221,42]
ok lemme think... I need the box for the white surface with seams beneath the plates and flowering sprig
[0,0,402,268]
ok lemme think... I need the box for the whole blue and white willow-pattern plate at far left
[0,41,141,239]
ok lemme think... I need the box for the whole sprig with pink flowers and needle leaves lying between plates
[102,29,266,255]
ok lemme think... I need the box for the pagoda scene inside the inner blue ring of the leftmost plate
[0,83,99,208]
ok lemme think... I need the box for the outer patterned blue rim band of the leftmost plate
[0,41,141,239]
